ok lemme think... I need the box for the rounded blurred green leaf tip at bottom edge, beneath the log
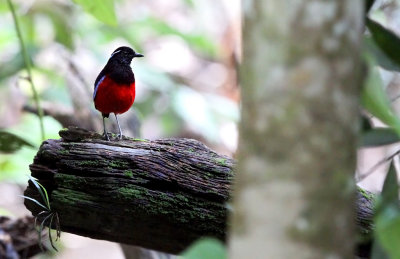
[181,238,227,259]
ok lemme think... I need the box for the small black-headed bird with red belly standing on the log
[93,46,144,141]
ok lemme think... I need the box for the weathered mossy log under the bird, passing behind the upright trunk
[25,128,373,254]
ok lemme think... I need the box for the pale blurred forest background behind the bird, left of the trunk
[0,0,241,258]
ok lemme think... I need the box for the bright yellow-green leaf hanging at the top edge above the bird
[73,0,117,26]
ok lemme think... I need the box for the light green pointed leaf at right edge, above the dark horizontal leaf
[361,60,400,134]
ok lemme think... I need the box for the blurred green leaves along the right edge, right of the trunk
[361,0,400,259]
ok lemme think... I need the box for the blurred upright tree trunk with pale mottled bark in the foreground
[230,0,363,258]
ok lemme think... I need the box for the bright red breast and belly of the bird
[94,75,135,114]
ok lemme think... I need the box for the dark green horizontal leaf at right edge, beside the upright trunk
[360,128,400,147]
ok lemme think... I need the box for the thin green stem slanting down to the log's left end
[7,0,45,140]
